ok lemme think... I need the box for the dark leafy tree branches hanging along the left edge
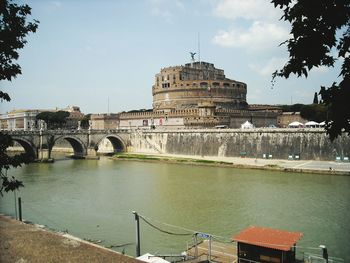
[0,0,39,195]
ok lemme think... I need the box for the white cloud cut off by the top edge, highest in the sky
[214,0,282,21]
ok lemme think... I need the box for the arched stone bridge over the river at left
[7,130,130,160]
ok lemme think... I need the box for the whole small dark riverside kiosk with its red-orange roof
[233,226,303,263]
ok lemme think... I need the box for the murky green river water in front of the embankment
[0,158,350,262]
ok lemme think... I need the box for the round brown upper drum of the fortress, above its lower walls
[152,62,247,111]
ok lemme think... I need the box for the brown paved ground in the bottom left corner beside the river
[0,215,142,263]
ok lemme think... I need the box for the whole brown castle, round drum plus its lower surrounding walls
[119,61,281,129]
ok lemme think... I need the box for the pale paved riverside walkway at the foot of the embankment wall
[129,153,350,175]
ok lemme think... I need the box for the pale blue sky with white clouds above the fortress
[0,0,339,114]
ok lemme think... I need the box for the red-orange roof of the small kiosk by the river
[232,226,303,251]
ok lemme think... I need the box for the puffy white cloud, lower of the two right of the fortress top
[213,21,289,50]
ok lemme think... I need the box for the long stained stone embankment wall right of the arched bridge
[128,129,350,160]
